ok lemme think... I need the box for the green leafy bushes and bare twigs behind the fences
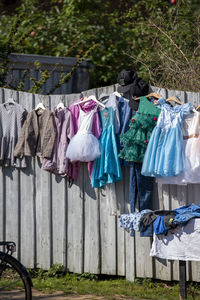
[0,0,200,91]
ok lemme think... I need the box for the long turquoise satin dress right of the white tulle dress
[91,107,122,188]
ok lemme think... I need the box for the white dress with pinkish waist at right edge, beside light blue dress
[157,110,200,185]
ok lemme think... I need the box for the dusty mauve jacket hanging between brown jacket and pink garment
[42,107,74,177]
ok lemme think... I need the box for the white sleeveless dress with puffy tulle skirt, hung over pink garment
[66,105,101,162]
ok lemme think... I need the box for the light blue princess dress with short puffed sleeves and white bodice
[141,98,192,177]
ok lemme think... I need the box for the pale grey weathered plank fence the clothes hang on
[0,85,200,281]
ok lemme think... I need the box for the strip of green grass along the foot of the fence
[25,264,200,300]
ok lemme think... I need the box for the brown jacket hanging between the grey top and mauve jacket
[14,109,56,158]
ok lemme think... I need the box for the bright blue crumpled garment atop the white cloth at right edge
[173,203,200,224]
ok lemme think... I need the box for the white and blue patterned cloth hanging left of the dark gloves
[119,209,151,236]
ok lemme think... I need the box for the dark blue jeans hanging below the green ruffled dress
[129,163,154,236]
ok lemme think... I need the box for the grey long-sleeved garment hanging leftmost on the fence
[0,102,27,168]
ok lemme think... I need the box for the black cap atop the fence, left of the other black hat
[117,69,138,93]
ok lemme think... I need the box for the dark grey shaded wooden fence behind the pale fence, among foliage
[3,53,92,94]
